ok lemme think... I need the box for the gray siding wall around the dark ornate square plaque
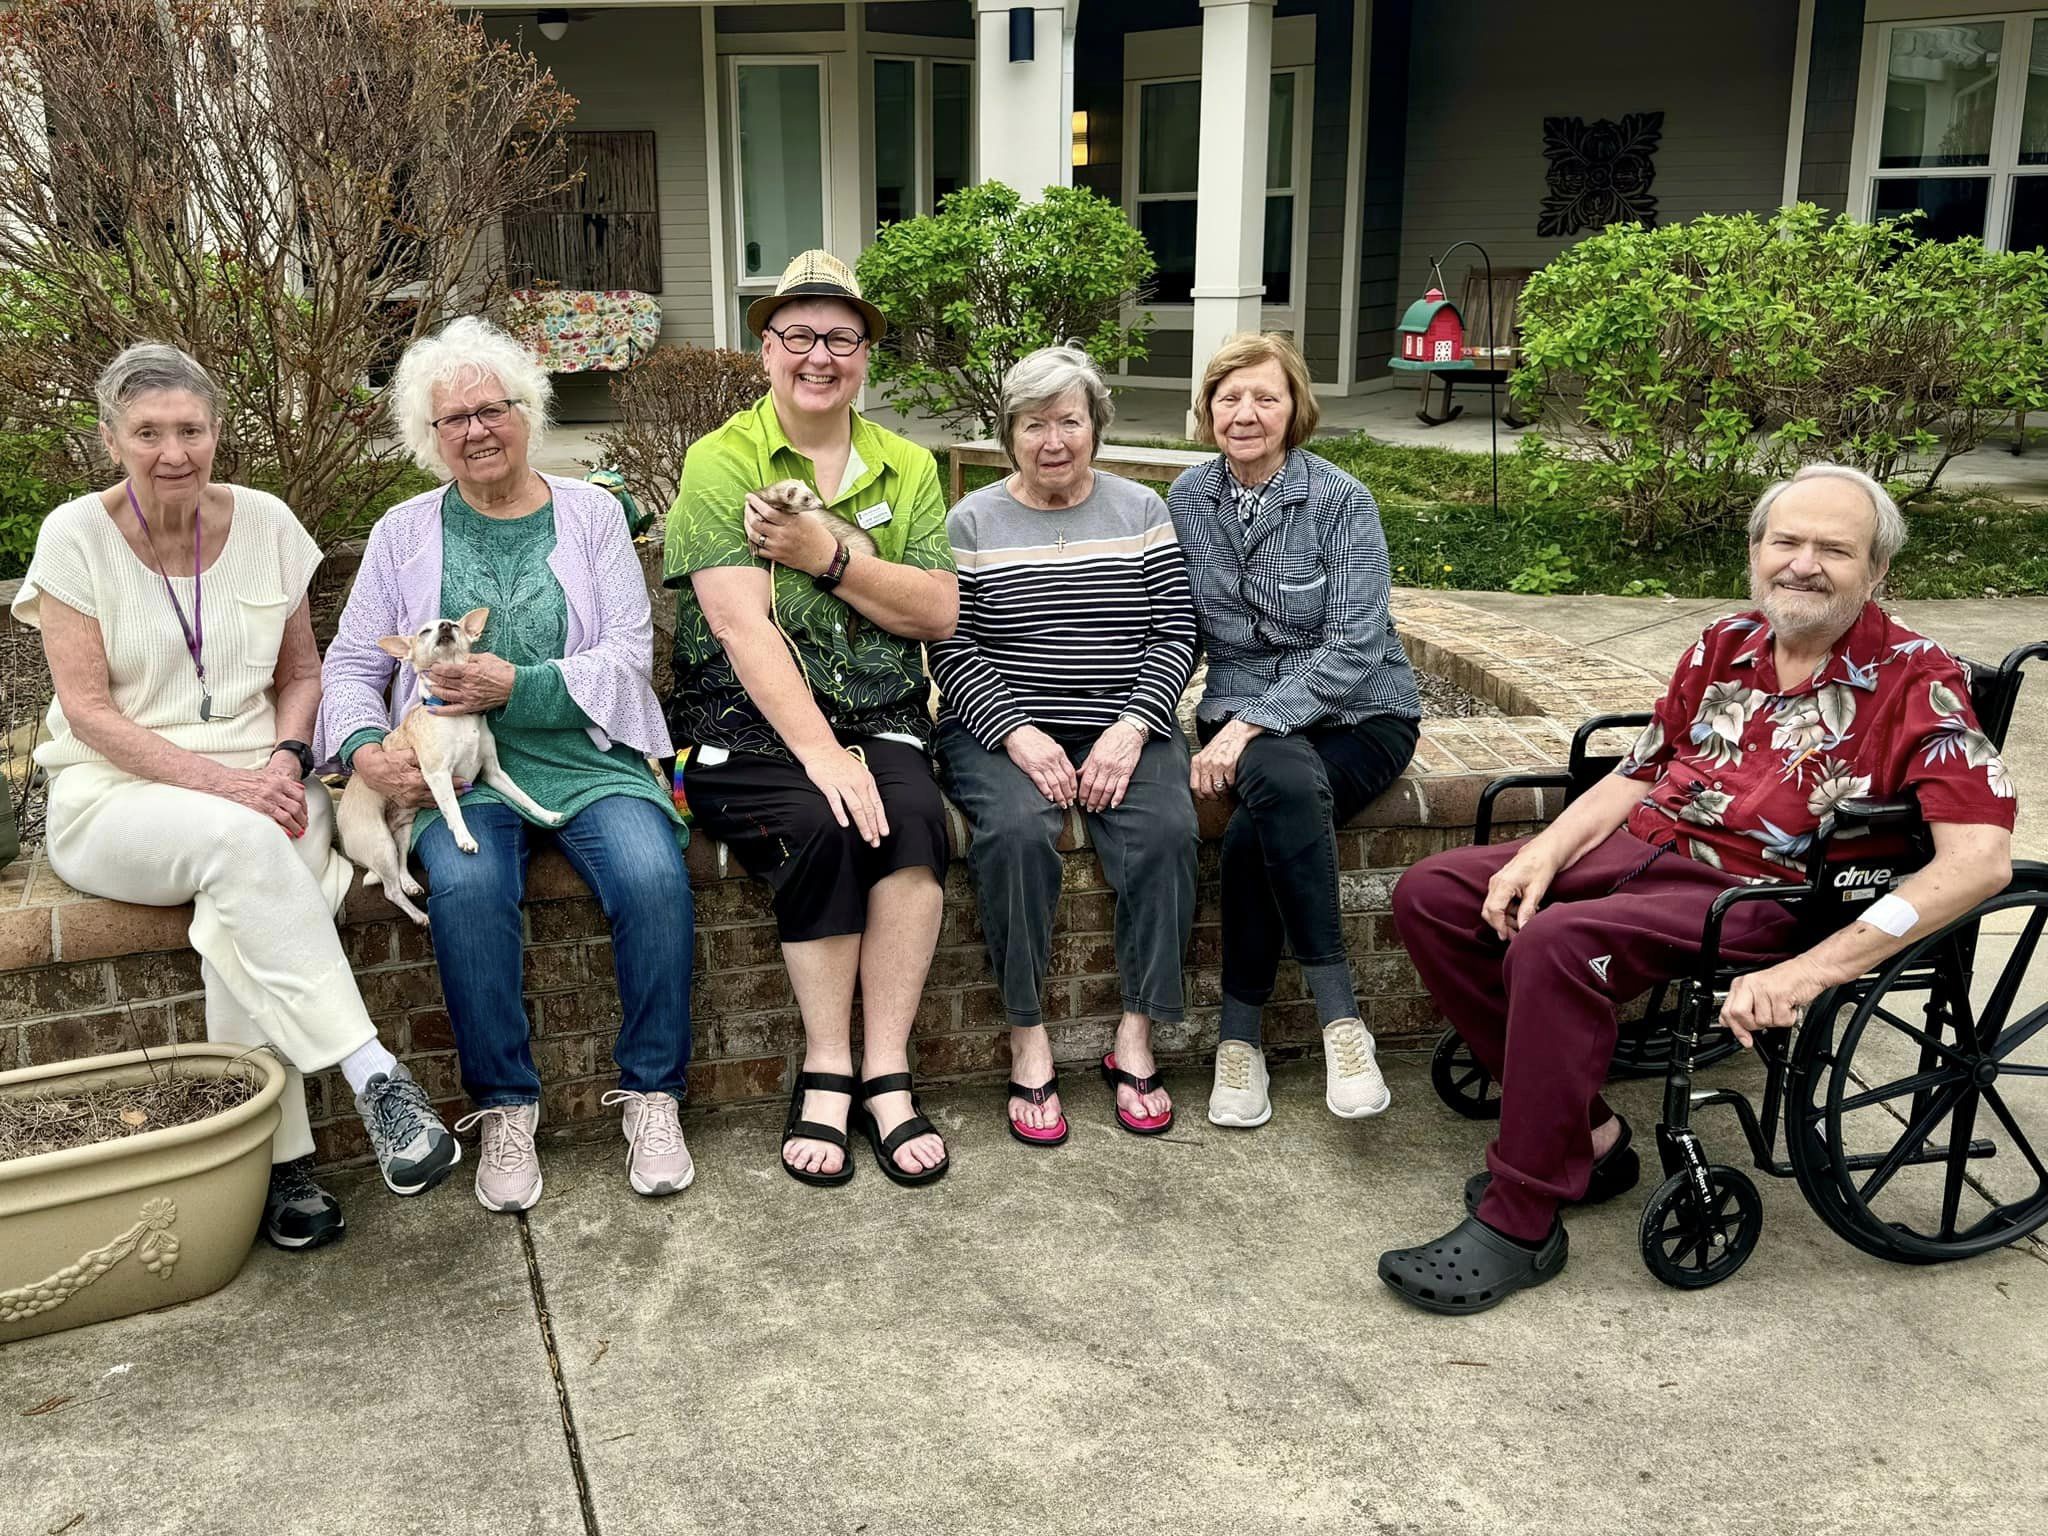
[1401,0,1798,313]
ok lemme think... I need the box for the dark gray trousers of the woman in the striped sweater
[938,721,1196,1026]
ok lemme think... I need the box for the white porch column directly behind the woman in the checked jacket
[1188,0,1274,432]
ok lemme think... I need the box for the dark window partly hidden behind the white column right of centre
[1135,70,1305,307]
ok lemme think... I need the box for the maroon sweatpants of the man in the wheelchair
[1395,831,1794,1243]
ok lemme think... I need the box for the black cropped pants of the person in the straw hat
[682,735,950,944]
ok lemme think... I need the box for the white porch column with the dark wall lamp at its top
[973,0,1081,199]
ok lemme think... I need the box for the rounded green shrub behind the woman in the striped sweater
[858,182,1153,434]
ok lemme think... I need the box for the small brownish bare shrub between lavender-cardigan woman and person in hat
[596,346,768,516]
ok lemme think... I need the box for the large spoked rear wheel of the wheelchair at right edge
[1788,891,2048,1264]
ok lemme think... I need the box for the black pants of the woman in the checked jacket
[1200,715,1417,1004]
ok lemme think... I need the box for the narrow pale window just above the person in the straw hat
[731,57,827,289]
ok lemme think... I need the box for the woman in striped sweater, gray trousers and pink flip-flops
[932,346,1196,1147]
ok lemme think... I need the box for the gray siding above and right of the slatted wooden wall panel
[483,6,713,346]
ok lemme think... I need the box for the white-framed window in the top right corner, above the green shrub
[1866,12,2048,250]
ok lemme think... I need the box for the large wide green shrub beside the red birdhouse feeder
[1513,203,2048,543]
